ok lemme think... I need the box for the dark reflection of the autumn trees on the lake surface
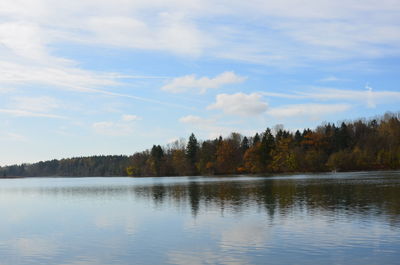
[132,172,400,224]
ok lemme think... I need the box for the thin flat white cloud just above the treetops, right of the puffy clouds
[267,103,351,118]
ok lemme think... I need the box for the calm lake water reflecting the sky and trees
[0,172,400,265]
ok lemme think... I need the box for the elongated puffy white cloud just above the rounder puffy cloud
[161,72,246,93]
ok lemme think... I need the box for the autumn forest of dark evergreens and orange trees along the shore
[0,112,400,177]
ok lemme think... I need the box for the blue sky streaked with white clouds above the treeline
[0,0,400,166]
